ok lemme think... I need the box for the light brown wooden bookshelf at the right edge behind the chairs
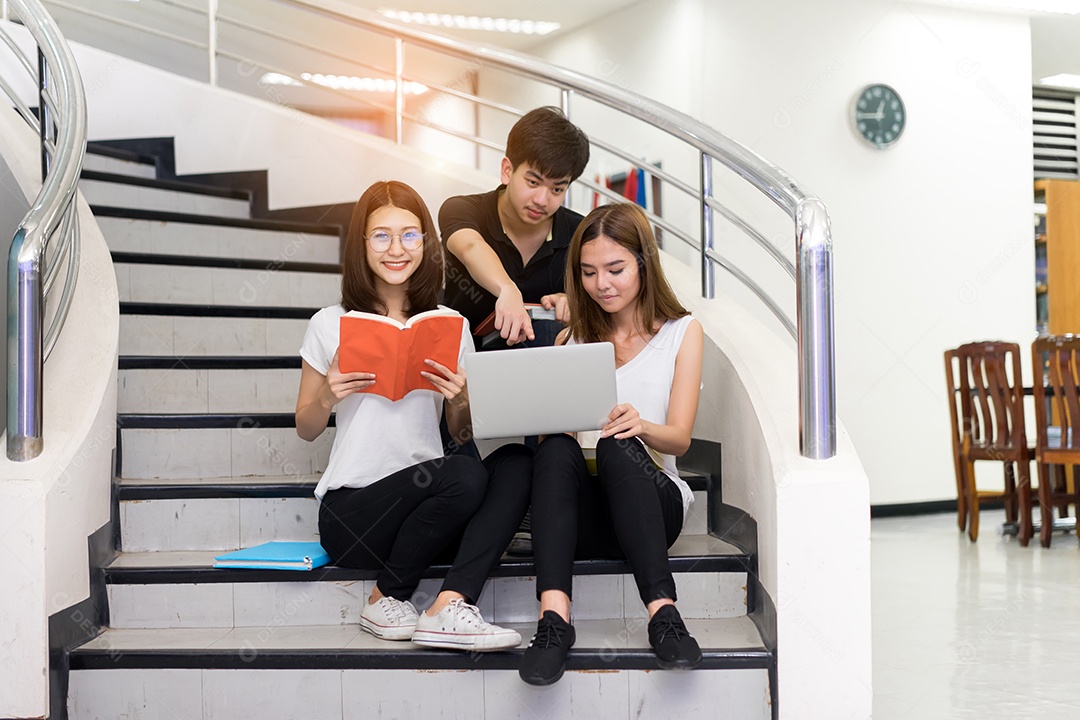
[1035,179,1080,335]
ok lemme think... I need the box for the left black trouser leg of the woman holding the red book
[319,456,487,600]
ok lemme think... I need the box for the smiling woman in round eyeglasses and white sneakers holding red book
[296,181,531,652]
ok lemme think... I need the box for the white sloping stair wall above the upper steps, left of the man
[63,37,492,214]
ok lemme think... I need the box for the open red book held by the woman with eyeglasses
[338,309,465,400]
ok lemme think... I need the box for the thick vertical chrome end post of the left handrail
[8,229,44,462]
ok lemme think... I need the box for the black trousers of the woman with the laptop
[532,435,683,604]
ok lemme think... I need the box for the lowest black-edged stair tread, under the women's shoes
[71,608,770,670]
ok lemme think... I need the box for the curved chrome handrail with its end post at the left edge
[3,0,86,461]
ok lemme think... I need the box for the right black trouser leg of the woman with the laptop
[596,437,683,604]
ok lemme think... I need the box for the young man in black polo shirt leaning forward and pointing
[438,107,589,345]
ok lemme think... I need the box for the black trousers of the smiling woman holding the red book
[319,445,532,602]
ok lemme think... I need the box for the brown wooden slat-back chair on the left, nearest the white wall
[945,342,1034,545]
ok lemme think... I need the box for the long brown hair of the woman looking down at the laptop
[566,203,690,342]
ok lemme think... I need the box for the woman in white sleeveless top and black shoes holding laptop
[518,203,704,685]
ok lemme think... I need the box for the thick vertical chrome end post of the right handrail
[795,199,836,460]
